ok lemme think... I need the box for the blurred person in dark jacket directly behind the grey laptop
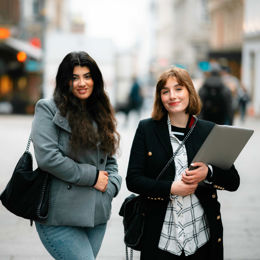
[199,67,232,125]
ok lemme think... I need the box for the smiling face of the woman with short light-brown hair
[161,77,189,114]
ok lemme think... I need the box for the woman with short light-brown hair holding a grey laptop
[126,68,239,260]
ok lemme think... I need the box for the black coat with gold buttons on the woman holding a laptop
[126,116,240,260]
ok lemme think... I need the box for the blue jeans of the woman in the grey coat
[35,222,106,260]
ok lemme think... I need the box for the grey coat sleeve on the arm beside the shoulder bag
[31,100,97,186]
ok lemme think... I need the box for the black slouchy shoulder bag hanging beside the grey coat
[0,137,50,225]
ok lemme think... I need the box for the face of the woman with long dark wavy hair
[72,66,94,100]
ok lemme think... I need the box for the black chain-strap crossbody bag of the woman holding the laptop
[119,117,198,260]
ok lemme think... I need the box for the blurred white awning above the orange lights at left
[4,38,42,60]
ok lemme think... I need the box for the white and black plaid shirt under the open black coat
[159,118,210,256]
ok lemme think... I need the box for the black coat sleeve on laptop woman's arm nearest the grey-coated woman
[126,121,172,197]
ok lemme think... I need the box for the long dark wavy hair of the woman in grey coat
[53,51,120,155]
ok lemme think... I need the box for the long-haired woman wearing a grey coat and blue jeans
[31,52,121,260]
